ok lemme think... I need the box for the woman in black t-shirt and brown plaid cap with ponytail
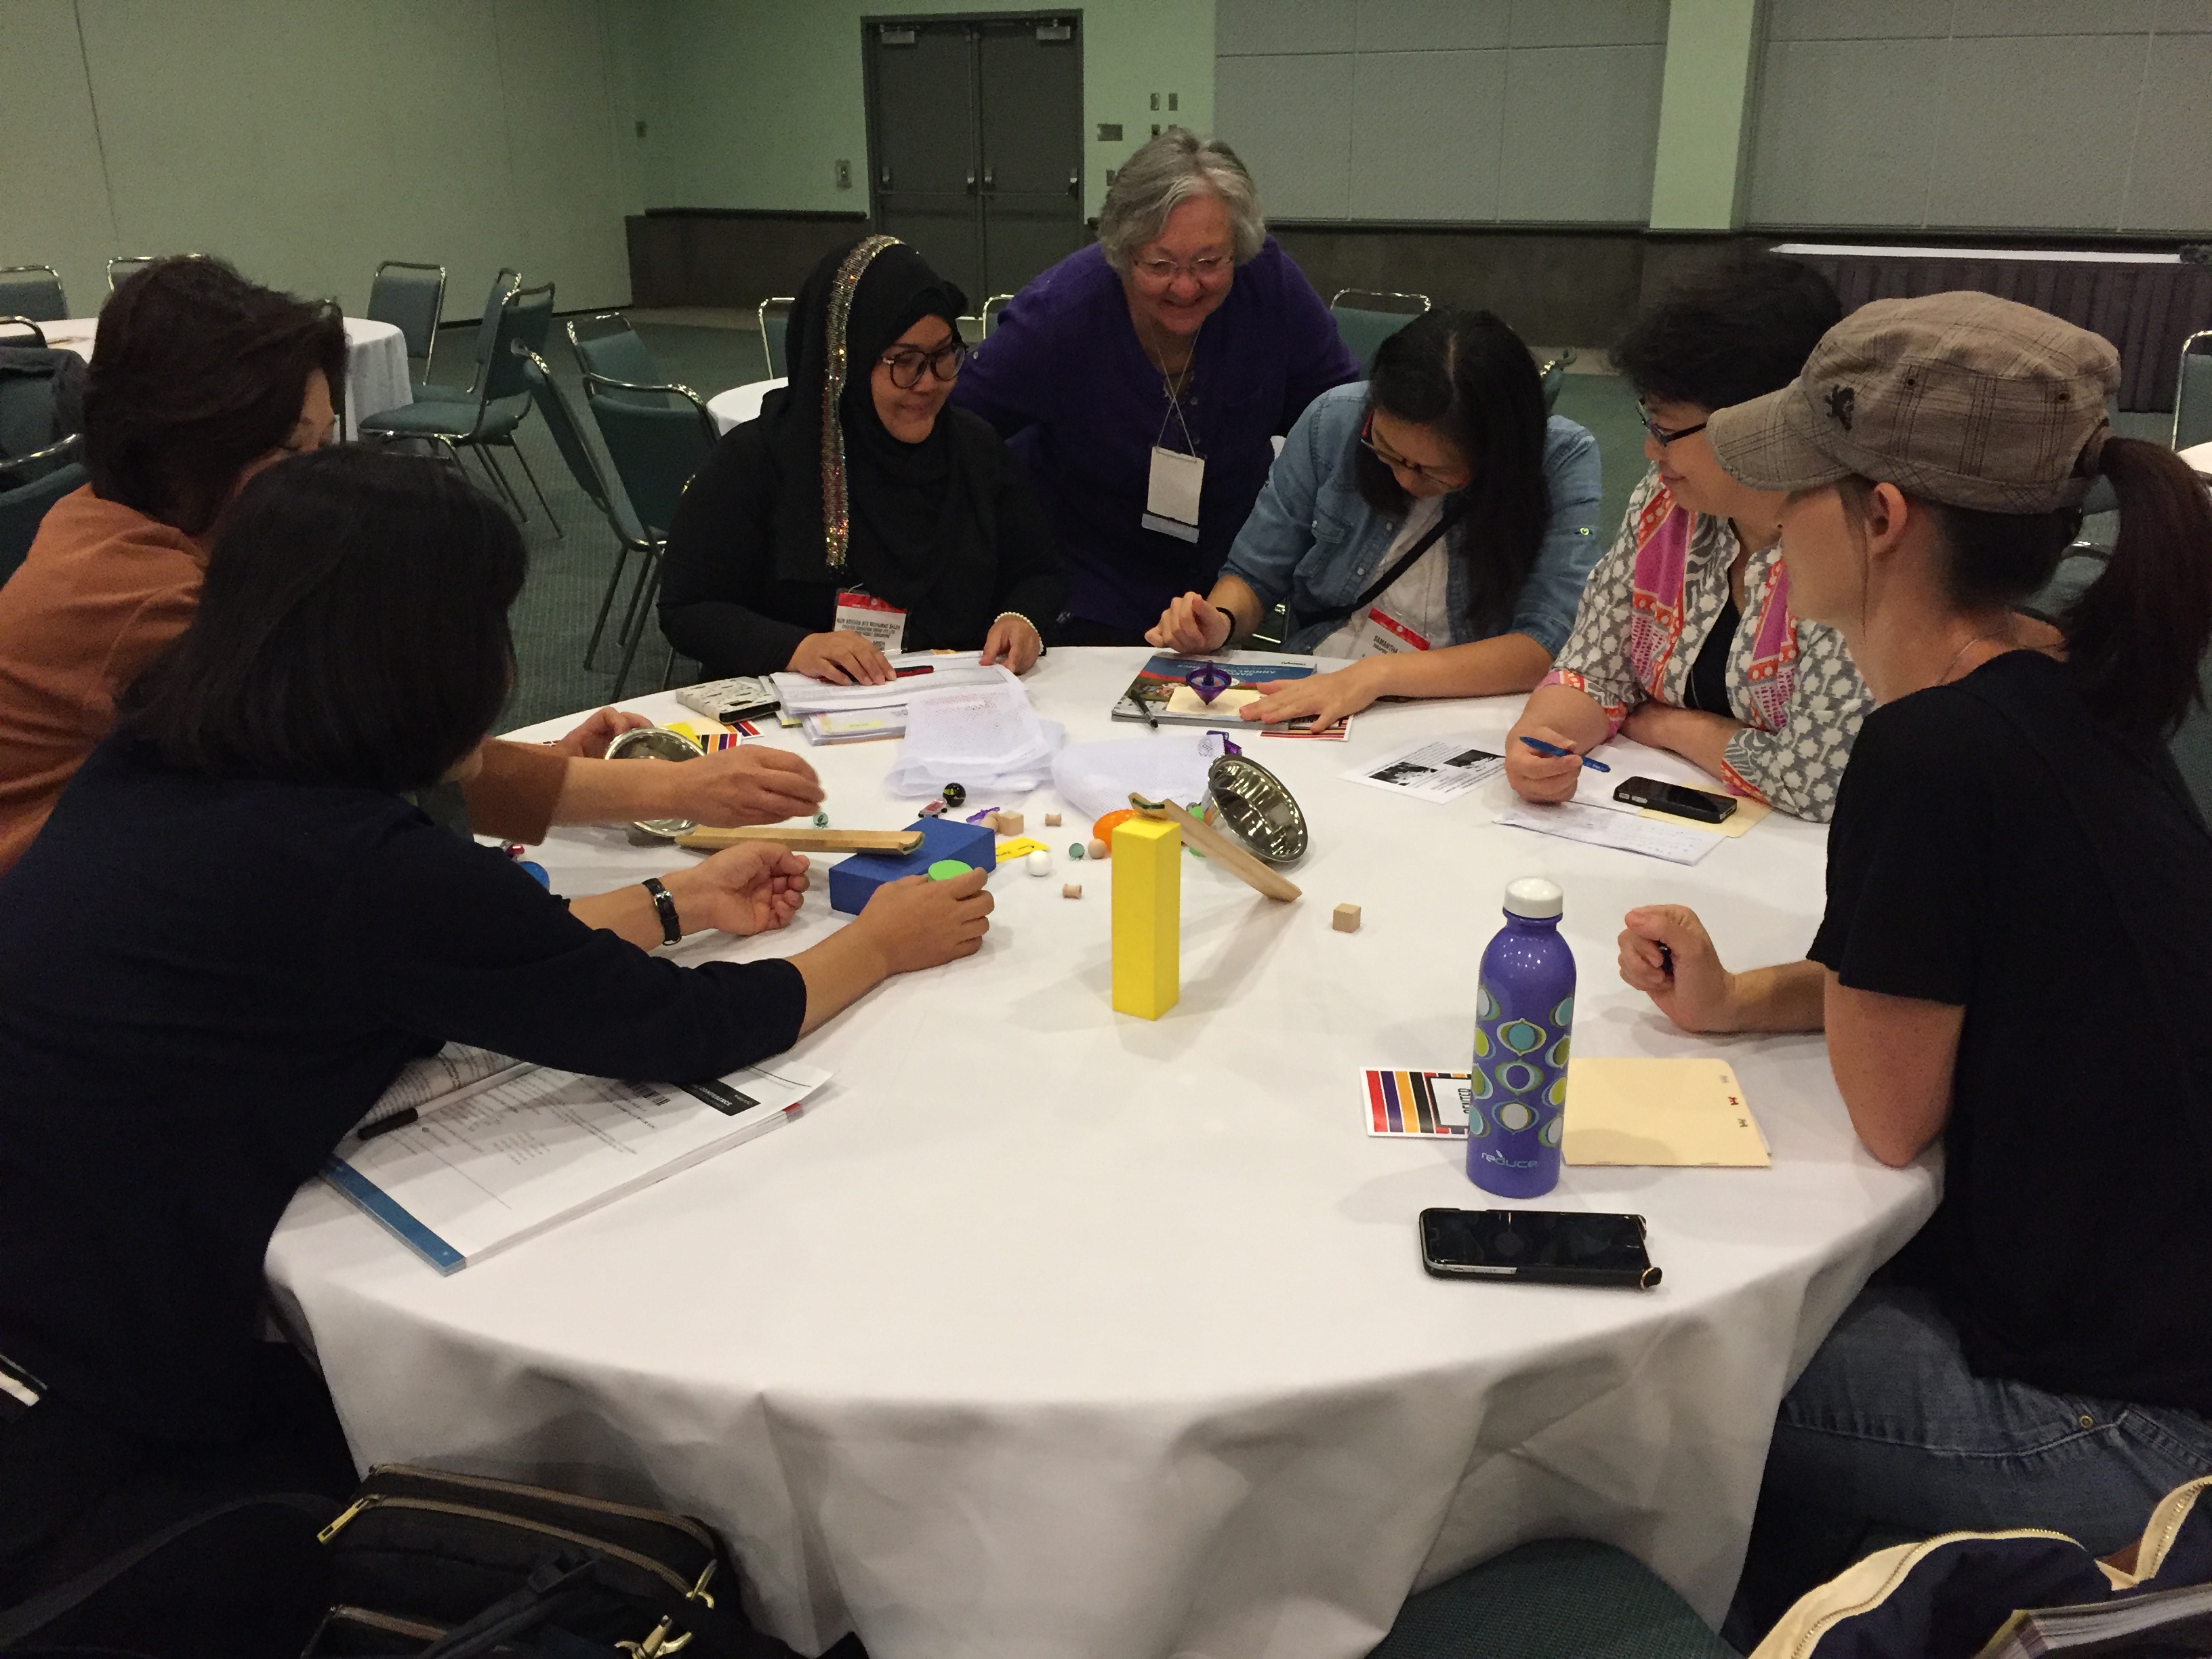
[1622,294,2212,1610]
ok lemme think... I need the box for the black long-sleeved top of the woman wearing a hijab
[661,405,1069,677]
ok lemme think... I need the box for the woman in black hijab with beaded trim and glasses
[661,237,1066,684]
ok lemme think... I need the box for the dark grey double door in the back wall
[861,14,1086,310]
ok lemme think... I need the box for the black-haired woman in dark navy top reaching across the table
[0,449,991,1603]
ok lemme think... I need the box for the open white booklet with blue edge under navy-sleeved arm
[323,1044,830,1274]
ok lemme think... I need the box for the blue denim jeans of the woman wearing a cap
[1761,1285,2212,1555]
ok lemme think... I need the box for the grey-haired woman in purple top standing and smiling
[954,126,1360,646]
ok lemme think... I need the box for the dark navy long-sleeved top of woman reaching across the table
[0,739,805,1440]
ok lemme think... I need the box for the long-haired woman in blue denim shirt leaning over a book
[1146,310,1599,726]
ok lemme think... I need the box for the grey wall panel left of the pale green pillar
[1214,0,1668,226]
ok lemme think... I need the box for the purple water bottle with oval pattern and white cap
[1467,876,1575,1199]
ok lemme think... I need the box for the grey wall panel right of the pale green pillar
[1748,0,2212,234]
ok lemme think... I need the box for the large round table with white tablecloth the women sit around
[268,651,1938,1659]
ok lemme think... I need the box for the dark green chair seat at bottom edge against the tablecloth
[1367,1537,1741,1659]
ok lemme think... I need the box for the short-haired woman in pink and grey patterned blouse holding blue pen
[1507,257,1871,823]
